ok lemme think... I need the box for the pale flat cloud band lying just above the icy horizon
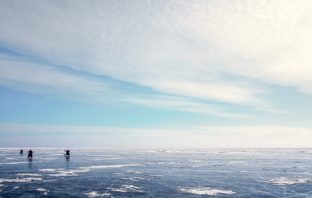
[0,124,312,148]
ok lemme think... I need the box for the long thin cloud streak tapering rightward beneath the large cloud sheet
[0,59,245,118]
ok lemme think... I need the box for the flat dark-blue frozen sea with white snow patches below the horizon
[0,148,312,198]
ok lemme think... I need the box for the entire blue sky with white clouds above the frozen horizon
[0,0,312,148]
